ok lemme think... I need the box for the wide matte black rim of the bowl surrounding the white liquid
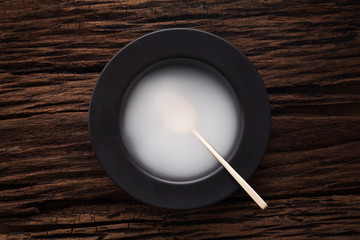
[89,28,270,209]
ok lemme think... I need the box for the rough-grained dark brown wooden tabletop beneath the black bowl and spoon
[0,0,360,239]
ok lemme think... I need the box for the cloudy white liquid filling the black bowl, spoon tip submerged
[120,60,241,181]
